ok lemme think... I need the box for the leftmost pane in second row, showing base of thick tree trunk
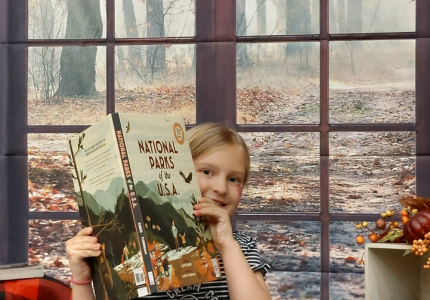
[28,47,106,125]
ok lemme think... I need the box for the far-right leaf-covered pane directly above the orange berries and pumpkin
[330,132,415,213]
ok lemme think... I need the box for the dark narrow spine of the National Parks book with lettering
[111,113,158,294]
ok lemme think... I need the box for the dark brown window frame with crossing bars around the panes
[0,0,430,300]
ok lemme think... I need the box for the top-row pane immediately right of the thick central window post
[236,0,319,36]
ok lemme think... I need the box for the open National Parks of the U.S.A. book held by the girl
[67,113,221,300]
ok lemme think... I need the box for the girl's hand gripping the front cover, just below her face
[193,197,235,255]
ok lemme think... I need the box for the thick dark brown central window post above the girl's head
[196,0,236,126]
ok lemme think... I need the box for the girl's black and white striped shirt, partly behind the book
[139,232,270,300]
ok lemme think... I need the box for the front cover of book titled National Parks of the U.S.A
[120,114,222,290]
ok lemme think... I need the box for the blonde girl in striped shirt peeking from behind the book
[66,123,271,300]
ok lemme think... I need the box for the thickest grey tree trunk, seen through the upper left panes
[59,0,103,97]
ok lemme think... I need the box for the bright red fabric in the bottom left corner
[0,276,72,300]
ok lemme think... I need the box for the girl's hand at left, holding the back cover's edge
[66,227,101,282]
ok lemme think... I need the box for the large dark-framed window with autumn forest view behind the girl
[0,0,430,300]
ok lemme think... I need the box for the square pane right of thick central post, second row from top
[237,43,320,124]
